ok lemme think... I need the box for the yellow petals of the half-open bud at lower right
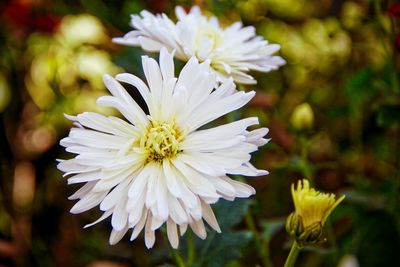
[292,180,344,228]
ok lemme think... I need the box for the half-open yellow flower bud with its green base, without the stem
[286,179,345,245]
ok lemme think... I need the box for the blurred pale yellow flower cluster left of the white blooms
[25,14,122,130]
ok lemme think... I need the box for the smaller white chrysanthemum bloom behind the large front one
[113,6,285,84]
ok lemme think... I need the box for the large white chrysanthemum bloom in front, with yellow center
[58,49,268,248]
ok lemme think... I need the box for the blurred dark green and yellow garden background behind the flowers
[0,0,400,267]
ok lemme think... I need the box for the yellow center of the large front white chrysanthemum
[139,120,185,163]
